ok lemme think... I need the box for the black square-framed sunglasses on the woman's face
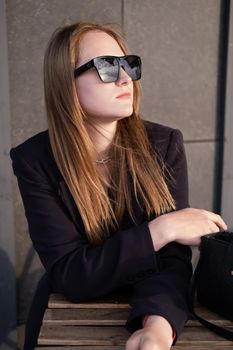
[74,55,142,83]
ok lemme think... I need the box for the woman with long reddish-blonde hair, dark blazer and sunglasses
[11,23,226,350]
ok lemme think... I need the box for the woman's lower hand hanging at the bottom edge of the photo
[125,316,173,350]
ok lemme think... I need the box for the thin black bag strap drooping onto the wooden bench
[189,264,233,341]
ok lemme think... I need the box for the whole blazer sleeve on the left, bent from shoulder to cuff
[10,149,158,301]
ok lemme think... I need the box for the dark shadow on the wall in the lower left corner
[0,245,44,349]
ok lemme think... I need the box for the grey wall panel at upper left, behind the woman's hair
[7,0,121,148]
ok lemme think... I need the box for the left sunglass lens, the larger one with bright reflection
[95,57,118,83]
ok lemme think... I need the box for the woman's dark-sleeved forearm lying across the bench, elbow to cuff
[50,224,158,301]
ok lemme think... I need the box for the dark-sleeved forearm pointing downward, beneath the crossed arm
[127,243,192,337]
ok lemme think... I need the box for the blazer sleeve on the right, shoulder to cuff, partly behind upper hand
[127,130,192,336]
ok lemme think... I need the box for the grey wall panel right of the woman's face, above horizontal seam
[124,0,220,140]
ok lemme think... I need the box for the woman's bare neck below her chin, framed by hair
[87,121,117,159]
